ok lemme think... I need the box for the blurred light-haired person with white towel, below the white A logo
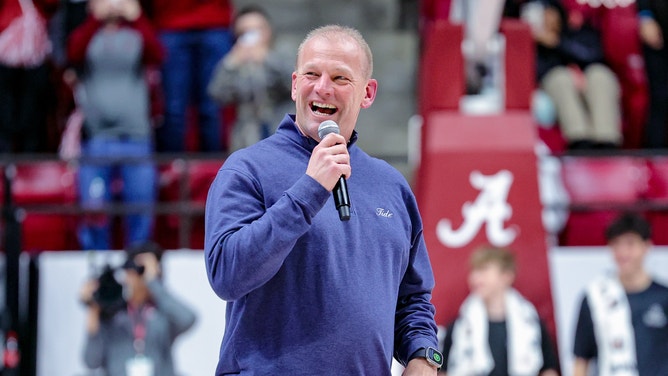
[441,247,559,376]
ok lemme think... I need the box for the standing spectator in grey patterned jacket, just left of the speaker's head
[208,6,294,151]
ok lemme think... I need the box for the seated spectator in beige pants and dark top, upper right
[528,0,622,149]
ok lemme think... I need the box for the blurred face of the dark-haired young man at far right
[608,232,651,276]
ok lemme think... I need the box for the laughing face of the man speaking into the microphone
[292,36,377,141]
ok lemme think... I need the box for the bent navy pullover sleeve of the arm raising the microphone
[204,166,329,301]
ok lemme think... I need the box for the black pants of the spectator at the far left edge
[0,64,49,153]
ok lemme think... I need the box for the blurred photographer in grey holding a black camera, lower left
[81,243,196,376]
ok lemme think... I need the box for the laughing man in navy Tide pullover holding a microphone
[205,26,442,376]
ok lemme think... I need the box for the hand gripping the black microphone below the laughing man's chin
[306,133,351,191]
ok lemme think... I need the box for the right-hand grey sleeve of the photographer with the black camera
[147,280,197,341]
